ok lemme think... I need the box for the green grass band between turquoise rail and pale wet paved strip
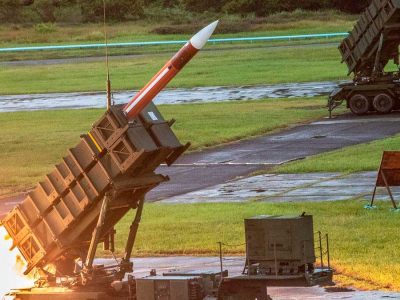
[0,45,346,94]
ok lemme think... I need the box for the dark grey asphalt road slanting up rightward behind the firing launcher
[0,113,400,217]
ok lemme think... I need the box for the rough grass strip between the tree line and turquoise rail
[0,10,358,47]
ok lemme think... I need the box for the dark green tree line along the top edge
[0,0,371,22]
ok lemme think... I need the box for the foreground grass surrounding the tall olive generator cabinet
[111,200,400,290]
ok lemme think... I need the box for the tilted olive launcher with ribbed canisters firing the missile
[2,103,189,299]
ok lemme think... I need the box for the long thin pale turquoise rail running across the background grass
[0,32,348,52]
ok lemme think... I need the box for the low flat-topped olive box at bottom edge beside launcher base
[136,276,205,300]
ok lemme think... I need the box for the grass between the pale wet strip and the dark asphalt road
[0,98,332,195]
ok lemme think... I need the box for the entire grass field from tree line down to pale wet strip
[0,11,356,94]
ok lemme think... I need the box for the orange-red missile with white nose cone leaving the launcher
[123,21,219,120]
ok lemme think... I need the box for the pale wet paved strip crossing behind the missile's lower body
[0,81,343,112]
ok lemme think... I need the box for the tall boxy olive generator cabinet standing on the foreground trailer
[245,216,316,276]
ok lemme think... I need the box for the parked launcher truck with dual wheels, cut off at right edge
[328,0,400,115]
